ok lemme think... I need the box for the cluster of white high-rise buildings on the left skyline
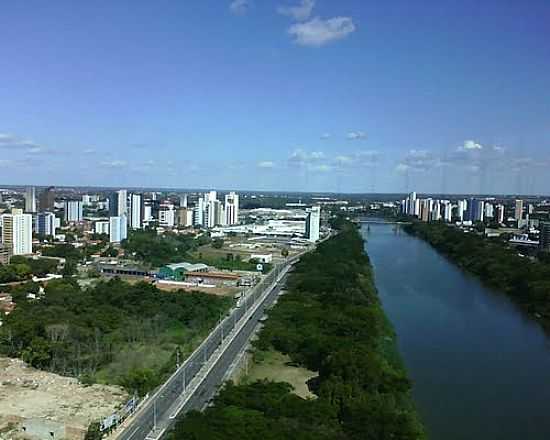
[0,187,244,263]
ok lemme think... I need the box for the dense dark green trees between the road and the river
[171,220,425,440]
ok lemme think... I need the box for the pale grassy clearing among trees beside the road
[241,351,317,398]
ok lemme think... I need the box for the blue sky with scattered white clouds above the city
[0,0,550,194]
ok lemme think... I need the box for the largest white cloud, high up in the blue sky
[288,17,355,47]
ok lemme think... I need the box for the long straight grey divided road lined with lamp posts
[115,265,291,440]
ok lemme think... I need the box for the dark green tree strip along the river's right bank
[406,222,550,329]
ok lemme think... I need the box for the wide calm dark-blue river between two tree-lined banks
[362,224,550,440]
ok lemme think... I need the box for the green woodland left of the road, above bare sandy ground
[0,278,231,394]
